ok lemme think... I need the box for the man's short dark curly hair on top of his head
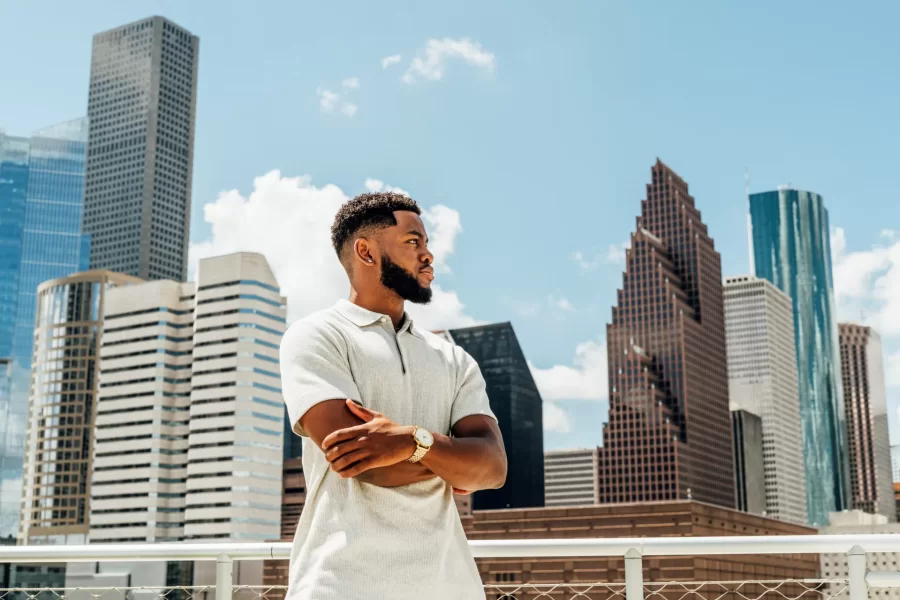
[331,192,422,262]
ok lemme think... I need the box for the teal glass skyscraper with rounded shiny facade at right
[750,188,849,525]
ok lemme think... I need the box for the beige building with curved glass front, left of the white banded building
[18,271,140,544]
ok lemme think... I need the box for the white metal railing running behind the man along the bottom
[0,534,900,600]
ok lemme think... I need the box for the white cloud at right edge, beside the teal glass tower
[831,228,900,336]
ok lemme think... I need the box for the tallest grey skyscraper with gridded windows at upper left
[84,17,200,281]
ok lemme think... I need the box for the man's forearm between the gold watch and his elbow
[419,434,506,492]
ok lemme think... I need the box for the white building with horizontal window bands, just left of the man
[90,253,286,543]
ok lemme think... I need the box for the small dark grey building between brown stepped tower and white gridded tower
[731,410,766,515]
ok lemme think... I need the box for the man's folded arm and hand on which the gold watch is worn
[322,401,507,492]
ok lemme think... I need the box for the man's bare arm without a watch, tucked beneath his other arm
[300,400,435,487]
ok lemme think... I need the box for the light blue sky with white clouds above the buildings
[0,0,900,449]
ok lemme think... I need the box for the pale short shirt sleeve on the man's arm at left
[279,320,360,436]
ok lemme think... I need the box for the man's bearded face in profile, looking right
[381,210,434,304]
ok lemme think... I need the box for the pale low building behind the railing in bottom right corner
[819,509,900,600]
